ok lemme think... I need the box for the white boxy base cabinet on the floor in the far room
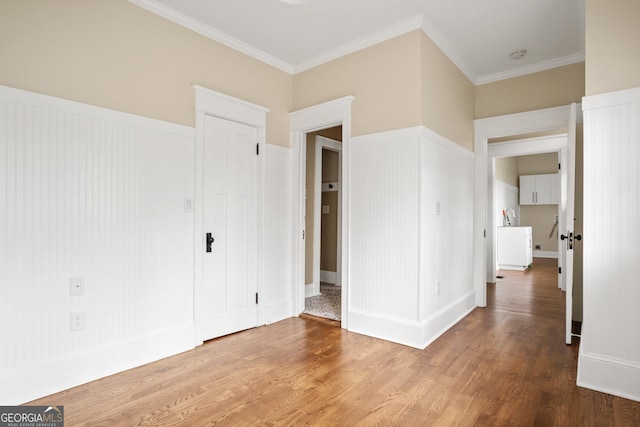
[498,227,533,270]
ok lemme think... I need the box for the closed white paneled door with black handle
[201,116,258,340]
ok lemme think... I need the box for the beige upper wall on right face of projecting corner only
[420,32,475,151]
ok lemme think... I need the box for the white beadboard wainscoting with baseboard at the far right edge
[577,88,640,401]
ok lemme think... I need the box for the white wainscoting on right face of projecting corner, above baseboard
[420,128,475,320]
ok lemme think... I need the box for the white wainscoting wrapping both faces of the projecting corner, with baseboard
[349,127,475,348]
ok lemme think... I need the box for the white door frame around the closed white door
[193,86,270,345]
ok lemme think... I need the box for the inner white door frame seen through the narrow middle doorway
[313,136,342,295]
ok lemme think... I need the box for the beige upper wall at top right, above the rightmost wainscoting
[585,0,640,95]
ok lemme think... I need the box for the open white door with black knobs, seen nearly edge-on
[558,103,581,344]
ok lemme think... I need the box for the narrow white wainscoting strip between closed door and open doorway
[260,144,293,324]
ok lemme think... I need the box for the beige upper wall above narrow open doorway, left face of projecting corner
[293,31,421,136]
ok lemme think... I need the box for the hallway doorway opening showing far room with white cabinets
[487,149,566,318]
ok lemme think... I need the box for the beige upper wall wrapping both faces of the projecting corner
[293,30,474,149]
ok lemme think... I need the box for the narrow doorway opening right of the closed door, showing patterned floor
[304,129,342,321]
